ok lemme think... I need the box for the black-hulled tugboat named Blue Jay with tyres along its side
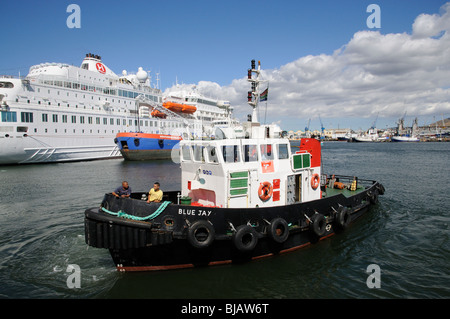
[85,60,384,271]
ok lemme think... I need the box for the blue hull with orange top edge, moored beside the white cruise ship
[115,133,181,161]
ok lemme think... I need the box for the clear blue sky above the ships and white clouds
[0,0,450,129]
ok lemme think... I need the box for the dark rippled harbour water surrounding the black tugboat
[0,142,450,299]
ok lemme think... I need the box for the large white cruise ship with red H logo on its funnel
[0,53,232,165]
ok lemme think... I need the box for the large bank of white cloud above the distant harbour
[163,3,450,127]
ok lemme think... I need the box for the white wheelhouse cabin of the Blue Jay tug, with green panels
[180,125,321,208]
